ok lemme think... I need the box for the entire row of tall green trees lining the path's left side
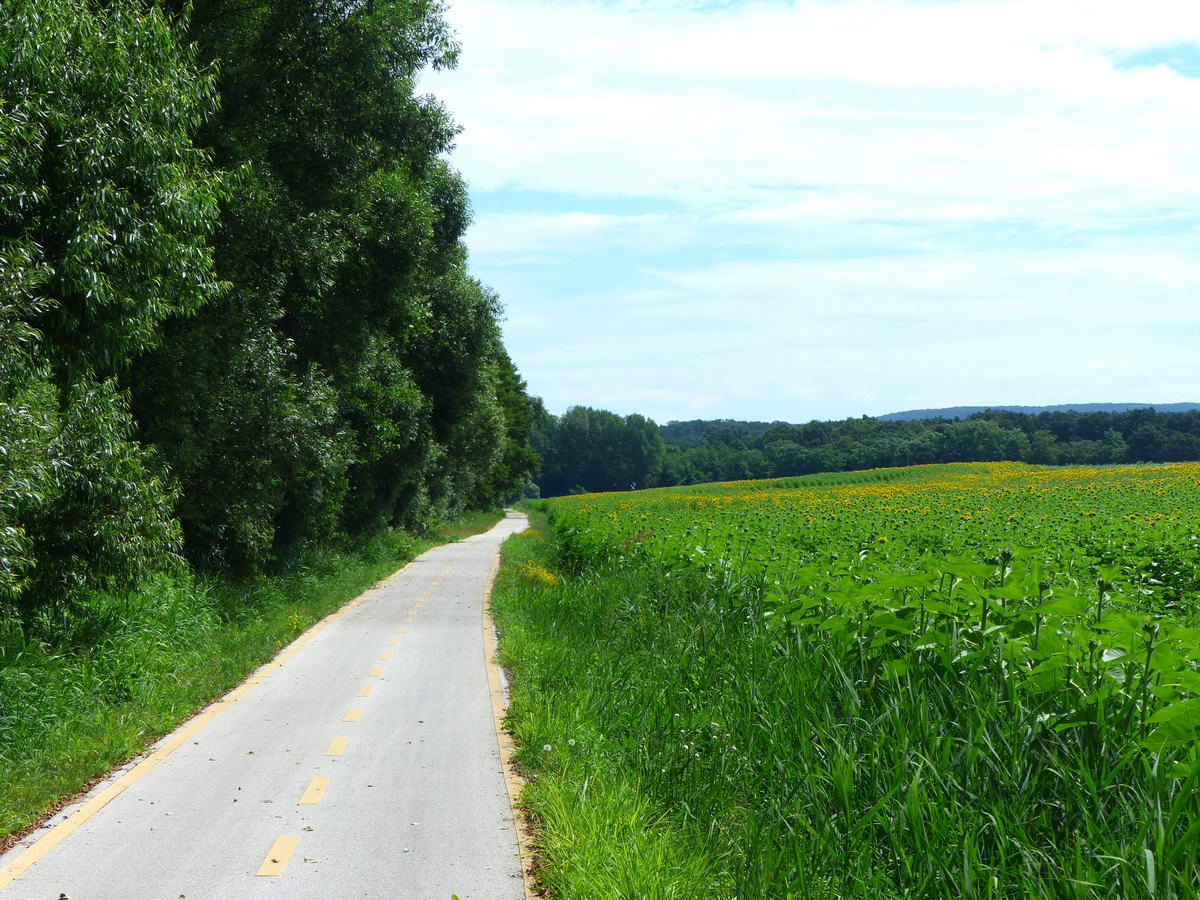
[0,0,536,625]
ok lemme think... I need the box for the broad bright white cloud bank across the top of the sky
[428,0,1200,203]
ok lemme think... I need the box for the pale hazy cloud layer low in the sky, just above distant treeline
[509,241,1200,420]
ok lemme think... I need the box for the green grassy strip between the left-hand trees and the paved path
[0,510,502,842]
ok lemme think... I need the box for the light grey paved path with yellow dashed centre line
[0,512,526,900]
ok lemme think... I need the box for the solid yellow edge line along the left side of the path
[0,553,412,889]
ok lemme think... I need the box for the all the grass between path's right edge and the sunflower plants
[493,511,1200,899]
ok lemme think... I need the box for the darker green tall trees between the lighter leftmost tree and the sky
[132,0,530,568]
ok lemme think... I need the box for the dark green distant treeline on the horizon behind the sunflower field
[534,407,1200,496]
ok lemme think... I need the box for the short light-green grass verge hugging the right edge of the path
[492,505,728,900]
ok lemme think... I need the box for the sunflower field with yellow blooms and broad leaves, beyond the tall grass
[554,463,1200,748]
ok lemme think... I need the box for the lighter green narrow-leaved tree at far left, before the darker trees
[0,0,222,619]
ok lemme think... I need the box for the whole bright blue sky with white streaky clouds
[420,0,1200,422]
